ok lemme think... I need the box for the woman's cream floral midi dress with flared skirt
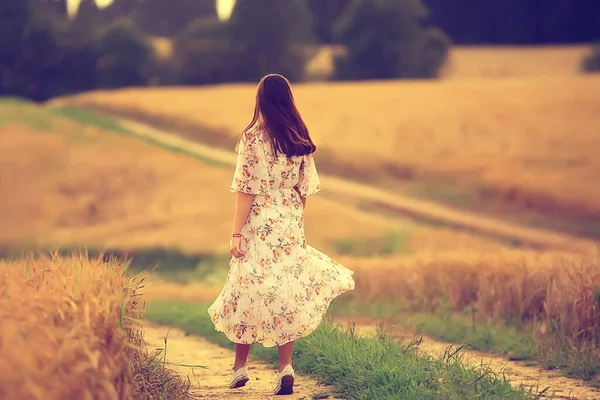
[208,130,354,347]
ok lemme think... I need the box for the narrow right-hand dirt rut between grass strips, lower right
[346,321,600,400]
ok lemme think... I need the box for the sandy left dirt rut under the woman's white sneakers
[144,324,333,400]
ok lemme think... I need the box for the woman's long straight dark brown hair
[236,74,317,156]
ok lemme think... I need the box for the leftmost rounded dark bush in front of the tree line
[90,19,153,88]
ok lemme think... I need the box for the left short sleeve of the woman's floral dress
[230,135,270,195]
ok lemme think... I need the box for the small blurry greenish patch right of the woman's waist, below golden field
[333,231,414,257]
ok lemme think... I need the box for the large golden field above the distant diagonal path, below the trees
[60,75,600,228]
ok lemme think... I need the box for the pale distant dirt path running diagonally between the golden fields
[70,112,596,253]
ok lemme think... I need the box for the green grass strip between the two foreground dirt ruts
[147,302,536,400]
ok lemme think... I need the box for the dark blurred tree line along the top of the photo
[0,0,597,101]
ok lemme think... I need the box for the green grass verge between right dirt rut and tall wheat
[328,293,600,387]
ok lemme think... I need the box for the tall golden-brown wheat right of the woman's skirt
[346,251,600,379]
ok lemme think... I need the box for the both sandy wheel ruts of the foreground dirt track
[144,325,600,400]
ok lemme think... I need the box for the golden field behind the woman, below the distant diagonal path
[0,104,503,254]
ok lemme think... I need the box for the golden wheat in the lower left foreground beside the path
[0,255,191,400]
